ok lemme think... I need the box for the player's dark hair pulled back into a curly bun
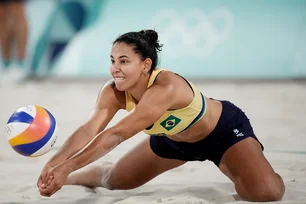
[113,30,163,74]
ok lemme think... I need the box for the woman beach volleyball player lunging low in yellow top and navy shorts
[37,30,285,201]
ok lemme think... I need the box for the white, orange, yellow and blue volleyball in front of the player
[6,105,57,157]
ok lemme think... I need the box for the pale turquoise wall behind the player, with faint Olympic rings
[1,0,306,79]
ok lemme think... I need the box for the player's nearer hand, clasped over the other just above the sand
[39,163,71,197]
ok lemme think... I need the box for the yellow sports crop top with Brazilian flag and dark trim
[125,69,206,136]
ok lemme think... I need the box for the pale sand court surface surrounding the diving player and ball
[0,80,306,204]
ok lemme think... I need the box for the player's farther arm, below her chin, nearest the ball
[48,82,121,166]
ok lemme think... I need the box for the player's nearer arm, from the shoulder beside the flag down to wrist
[63,84,175,172]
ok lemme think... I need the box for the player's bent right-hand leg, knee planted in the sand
[219,137,285,202]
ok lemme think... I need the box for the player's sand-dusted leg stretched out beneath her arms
[65,137,185,190]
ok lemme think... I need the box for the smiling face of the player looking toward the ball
[110,43,145,91]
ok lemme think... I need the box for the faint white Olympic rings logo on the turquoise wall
[152,8,234,58]
